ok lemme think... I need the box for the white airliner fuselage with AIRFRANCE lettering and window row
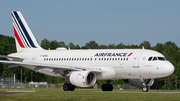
[9,48,174,80]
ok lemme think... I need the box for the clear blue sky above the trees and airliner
[0,0,180,47]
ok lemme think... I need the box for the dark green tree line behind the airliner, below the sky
[0,34,180,89]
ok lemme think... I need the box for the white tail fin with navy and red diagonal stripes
[11,11,43,52]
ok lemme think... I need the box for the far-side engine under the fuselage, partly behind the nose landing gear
[128,79,154,88]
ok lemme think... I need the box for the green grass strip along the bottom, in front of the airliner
[0,88,180,101]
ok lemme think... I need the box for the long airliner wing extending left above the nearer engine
[0,60,102,73]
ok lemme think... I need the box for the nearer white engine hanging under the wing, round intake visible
[69,71,96,87]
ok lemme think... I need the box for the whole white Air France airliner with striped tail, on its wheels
[0,11,174,92]
